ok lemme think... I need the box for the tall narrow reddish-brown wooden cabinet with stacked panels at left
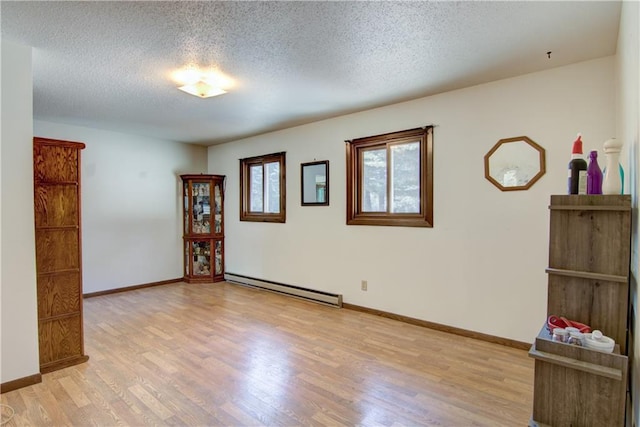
[33,137,89,373]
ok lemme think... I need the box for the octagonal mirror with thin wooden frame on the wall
[484,136,545,191]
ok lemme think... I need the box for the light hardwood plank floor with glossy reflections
[0,282,533,427]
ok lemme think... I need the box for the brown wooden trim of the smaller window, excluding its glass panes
[240,152,287,223]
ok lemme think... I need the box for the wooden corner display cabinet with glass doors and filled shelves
[180,175,225,283]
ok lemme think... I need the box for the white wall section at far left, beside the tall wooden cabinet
[0,41,40,383]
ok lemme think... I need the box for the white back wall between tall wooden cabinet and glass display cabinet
[34,120,207,293]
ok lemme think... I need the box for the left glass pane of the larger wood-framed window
[361,148,387,212]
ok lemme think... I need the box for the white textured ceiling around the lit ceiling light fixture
[0,1,621,145]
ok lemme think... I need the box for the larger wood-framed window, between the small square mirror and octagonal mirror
[346,126,433,227]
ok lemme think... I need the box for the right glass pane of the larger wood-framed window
[390,142,420,213]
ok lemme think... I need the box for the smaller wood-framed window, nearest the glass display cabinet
[240,153,286,222]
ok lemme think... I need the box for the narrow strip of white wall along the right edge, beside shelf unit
[616,1,640,426]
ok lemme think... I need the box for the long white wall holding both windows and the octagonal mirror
[209,57,615,342]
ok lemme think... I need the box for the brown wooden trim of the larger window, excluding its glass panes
[346,126,433,227]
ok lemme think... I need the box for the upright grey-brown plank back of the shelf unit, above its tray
[547,196,631,354]
